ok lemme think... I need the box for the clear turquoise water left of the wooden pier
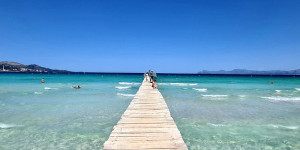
[0,74,142,150]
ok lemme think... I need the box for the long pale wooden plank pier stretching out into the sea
[103,79,187,150]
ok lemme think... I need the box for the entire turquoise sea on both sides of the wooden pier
[0,74,300,150]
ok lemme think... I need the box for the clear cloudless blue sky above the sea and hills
[0,0,300,73]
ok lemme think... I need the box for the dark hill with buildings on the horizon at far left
[0,61,70,73]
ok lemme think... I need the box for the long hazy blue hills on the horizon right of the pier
[198,69,300,75]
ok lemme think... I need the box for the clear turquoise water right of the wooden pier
[159,76,300,150]
